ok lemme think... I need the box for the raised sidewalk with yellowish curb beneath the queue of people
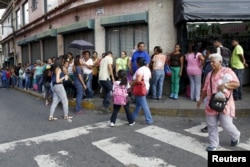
[15,86,250,117]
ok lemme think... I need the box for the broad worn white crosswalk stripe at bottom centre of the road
[92,137,175,167]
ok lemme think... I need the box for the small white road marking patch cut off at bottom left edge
[34,155,62,167]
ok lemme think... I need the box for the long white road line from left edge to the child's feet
[0,120,126,153]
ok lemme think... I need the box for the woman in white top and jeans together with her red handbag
[131,57,153,125]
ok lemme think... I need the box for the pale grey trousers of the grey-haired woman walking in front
[206,113,240,147]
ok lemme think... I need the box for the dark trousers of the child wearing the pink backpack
[110,102,134,124]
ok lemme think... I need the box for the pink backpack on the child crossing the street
[112,82,128,106]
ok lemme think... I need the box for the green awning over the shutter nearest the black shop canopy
[101,12,148,27]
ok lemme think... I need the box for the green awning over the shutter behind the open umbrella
[57,19,95,34]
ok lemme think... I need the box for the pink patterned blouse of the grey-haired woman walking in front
[203,67,239,117]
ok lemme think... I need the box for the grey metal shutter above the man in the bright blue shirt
[106,24,148,57]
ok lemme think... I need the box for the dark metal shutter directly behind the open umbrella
[63,30,94,56]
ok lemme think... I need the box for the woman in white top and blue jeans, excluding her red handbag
[131,57,153,125]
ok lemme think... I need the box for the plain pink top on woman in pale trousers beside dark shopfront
[186,52,202,75]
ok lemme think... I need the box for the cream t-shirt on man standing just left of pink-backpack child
[99,56,113,81]
